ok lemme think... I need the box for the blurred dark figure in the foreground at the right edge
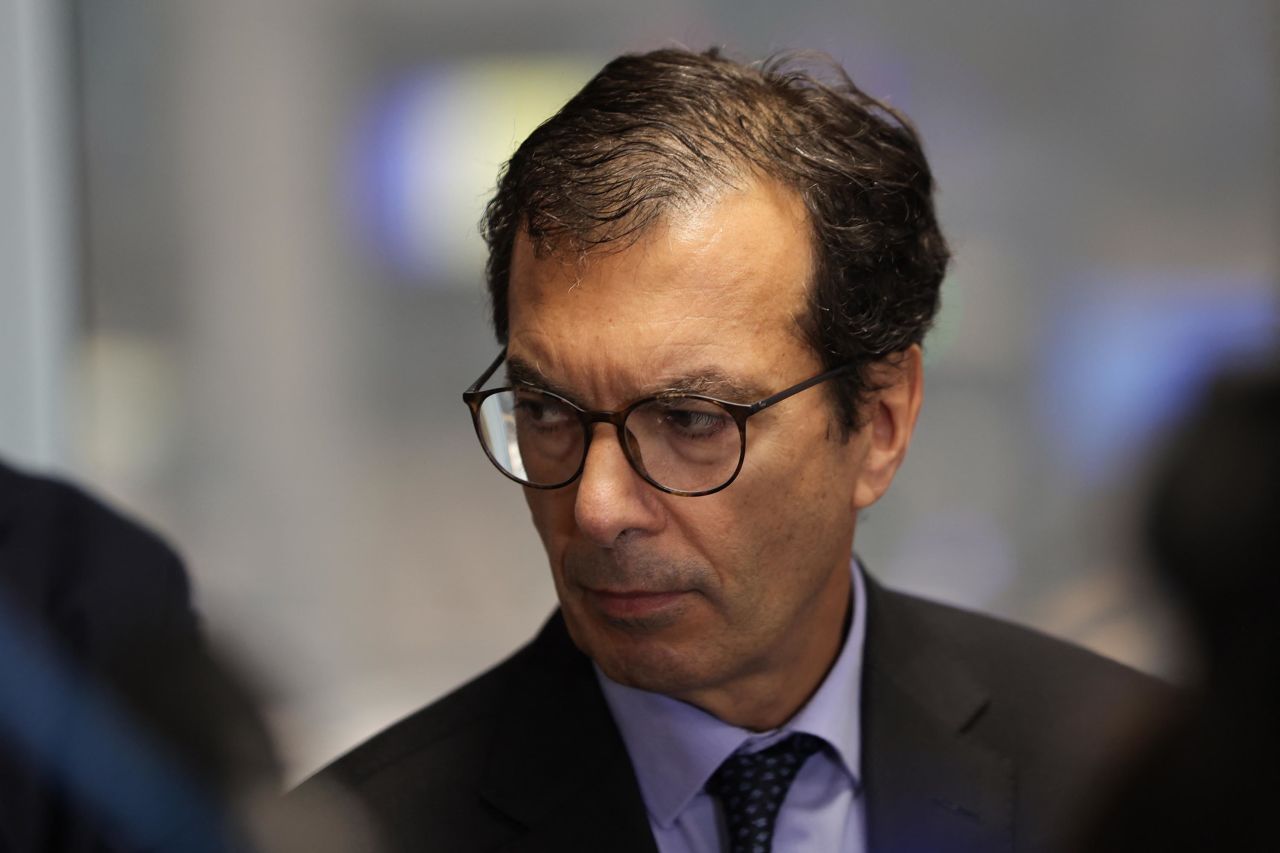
[1075,360,1280,853]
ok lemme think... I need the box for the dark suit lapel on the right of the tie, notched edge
[863,579,1014,853]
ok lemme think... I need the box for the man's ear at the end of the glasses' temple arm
[854,345,924,510]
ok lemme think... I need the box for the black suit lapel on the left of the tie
[481,613,657,853]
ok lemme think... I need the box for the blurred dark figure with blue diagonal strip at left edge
[0,462,371,853]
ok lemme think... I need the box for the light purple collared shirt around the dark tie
[595,561,867,853]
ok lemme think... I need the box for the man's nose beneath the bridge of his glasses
[573,424,666,548]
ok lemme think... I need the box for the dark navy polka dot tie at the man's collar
[707,733,823,853]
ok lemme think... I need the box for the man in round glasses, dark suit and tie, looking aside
[302,50,1162,853]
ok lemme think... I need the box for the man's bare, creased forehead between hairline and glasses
[508,184,817,399]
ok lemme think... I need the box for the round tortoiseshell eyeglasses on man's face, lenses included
[462,348,855,497]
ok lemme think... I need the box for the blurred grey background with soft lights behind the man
[0,0,1280,779]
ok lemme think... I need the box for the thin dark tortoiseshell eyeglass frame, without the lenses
[462,347,858,497]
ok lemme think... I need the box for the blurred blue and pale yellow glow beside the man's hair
[346,54,595,288]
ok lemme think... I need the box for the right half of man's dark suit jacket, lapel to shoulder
[863,583,1174,850]
